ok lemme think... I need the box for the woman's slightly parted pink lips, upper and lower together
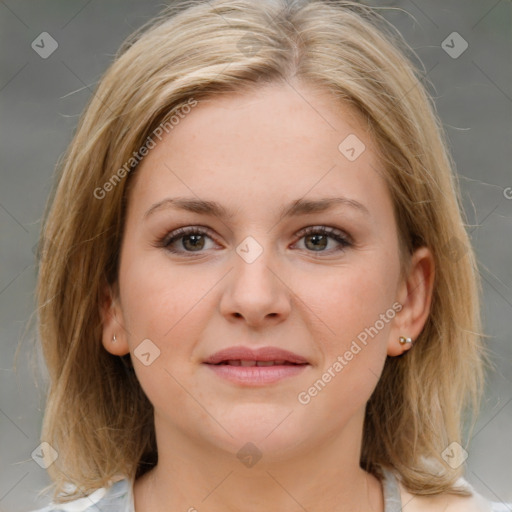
[203,346,310,386]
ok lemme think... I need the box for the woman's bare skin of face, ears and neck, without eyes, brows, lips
[103,83,434,512]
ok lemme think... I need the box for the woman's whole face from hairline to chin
[104,84,430,460]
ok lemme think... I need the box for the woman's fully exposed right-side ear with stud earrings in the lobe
[387,247,435,356]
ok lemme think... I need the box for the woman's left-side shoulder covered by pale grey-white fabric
[28,478,134,512]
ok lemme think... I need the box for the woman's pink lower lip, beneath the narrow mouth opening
[206,364,309,386]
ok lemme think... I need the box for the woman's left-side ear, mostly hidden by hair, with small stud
[100,285,130,356]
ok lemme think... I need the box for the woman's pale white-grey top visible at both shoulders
[33,468,512,512]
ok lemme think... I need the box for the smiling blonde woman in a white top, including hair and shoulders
[33,0,506,512]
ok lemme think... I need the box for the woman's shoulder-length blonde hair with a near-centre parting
[34,0,487,501]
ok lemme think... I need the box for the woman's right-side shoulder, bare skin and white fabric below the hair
[400,478,512,512]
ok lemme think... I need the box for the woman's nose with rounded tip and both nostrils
[220,243,293,328]
